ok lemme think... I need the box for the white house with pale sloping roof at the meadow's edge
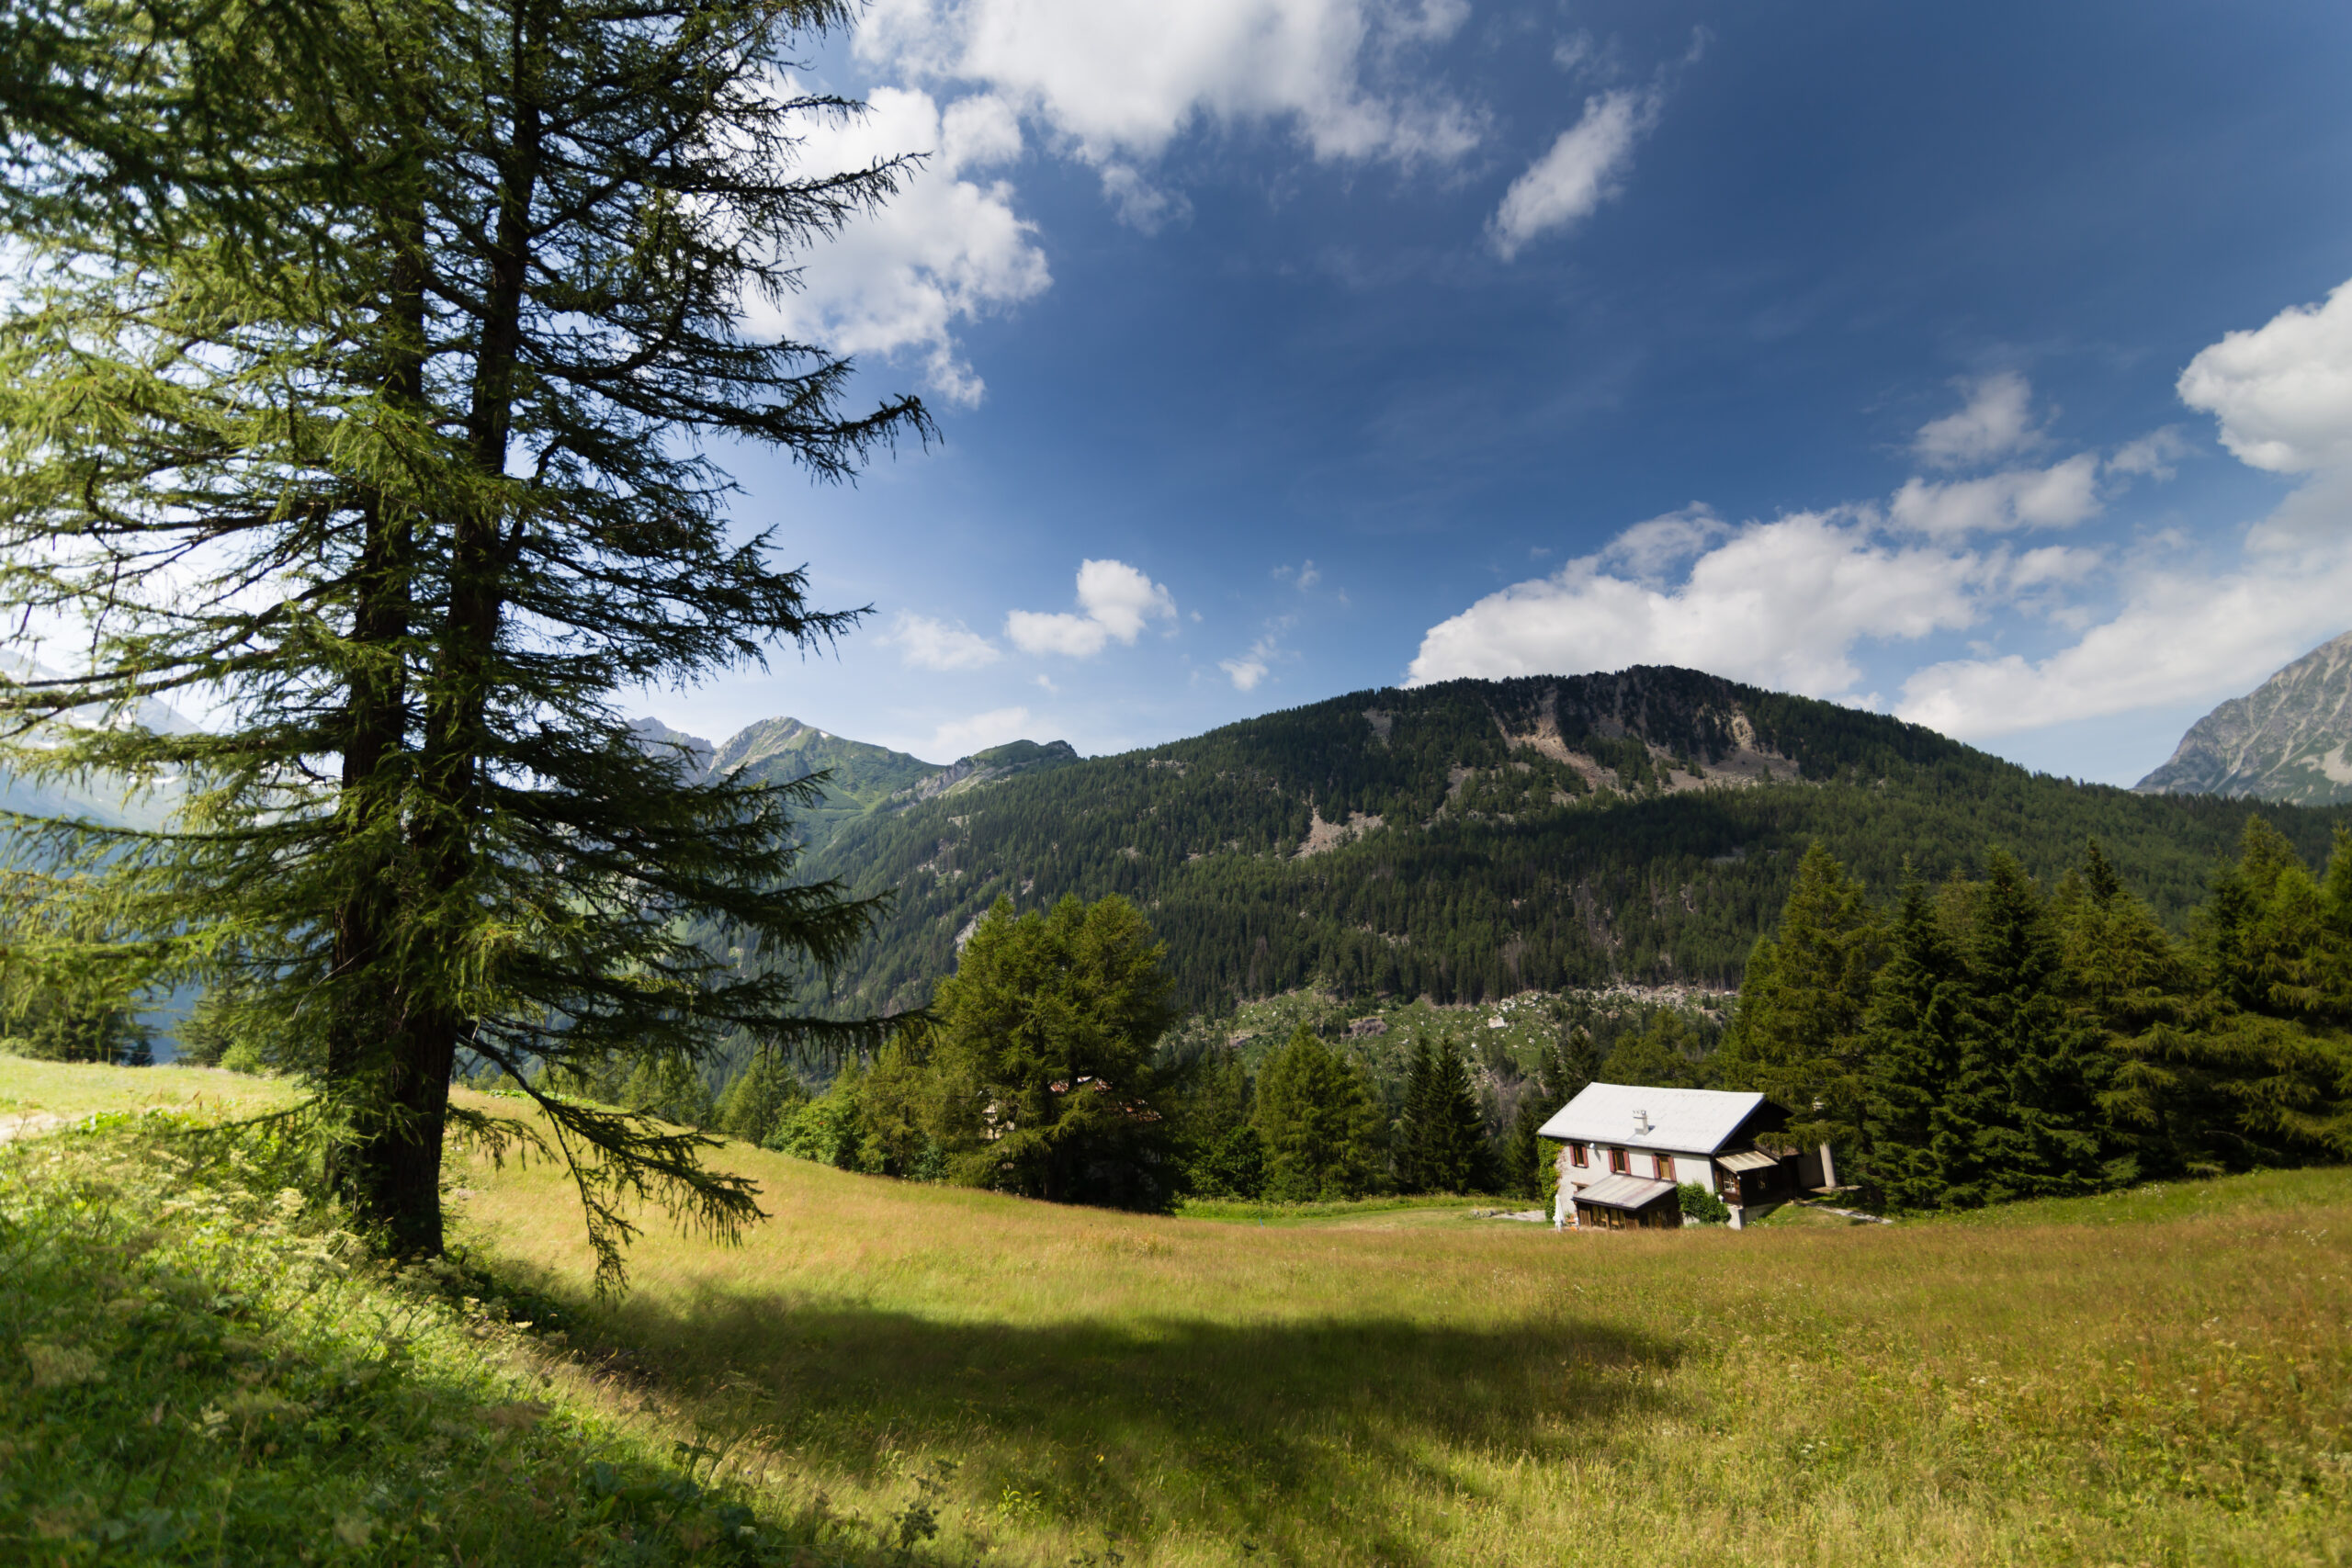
[1538,1084,1837,1229]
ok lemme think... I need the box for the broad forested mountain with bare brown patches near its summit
[805,668,2334,1010]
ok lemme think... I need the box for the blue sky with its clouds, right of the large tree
[644,0,2352,783]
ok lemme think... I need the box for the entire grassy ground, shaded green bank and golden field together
[0,1060,2352,1568]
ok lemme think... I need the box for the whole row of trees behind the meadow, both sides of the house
[682,816,2352,1211]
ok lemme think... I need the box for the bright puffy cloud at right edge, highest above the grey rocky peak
[2178,282,2352,472]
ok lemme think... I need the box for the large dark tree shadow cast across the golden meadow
[552,1295,1681,1563]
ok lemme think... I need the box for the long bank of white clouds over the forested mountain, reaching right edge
[1408,285,2352,740]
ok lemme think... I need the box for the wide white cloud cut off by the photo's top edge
[856,0,1477,173]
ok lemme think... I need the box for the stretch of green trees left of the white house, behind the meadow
[602,894,1698,1208]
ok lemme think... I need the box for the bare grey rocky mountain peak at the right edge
[2133,632,2352,807]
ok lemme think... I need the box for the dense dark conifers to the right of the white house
[1687,816,2352,1208]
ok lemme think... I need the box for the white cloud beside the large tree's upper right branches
[748,87,1054,404]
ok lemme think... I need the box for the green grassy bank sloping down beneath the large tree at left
[0,1060,924,1568]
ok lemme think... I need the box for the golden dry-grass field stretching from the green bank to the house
[461,1090,2352,1568]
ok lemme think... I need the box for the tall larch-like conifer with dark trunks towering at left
[0,0,927,1281]
